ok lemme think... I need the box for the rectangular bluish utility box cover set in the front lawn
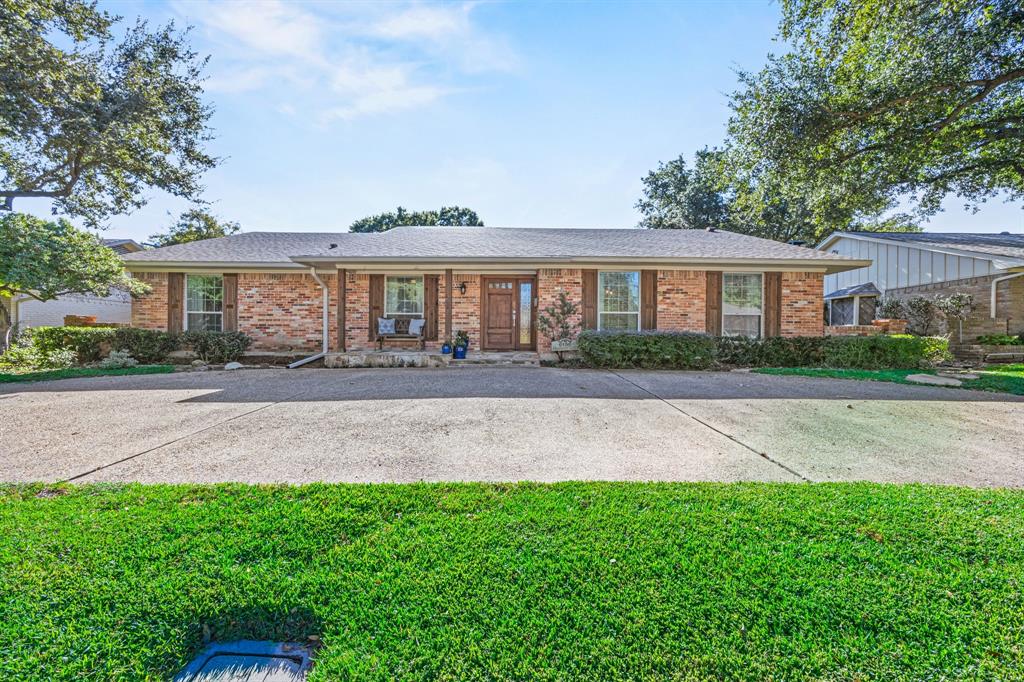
[174,640,312,682]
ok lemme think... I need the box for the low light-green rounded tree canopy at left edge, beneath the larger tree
[0,213,148,301]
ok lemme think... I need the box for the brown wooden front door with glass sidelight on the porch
[480,276,537,350]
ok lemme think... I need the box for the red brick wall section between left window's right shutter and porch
[239,272,338,352]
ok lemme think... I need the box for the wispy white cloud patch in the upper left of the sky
[175,0,517,118]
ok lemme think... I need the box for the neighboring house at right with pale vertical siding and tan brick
[818,232,1024,340]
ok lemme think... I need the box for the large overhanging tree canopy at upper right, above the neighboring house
[726,0,1024,227]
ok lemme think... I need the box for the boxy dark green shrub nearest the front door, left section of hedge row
[577,331,716,370]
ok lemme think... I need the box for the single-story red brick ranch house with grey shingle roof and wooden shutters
[124,227,869,354]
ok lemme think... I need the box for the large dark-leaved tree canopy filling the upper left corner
[0,0,217,226]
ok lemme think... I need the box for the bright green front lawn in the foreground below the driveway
[0,483,1024,681]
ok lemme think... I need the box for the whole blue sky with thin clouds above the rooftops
[28,0,1024,239]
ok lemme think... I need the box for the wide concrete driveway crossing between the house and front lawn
[0,368,1024,486]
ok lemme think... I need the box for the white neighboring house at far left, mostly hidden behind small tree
[12,240,142,328]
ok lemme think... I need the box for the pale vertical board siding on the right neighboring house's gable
[825,237,1001,294]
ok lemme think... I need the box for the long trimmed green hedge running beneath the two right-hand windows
[578,331,950,370]
